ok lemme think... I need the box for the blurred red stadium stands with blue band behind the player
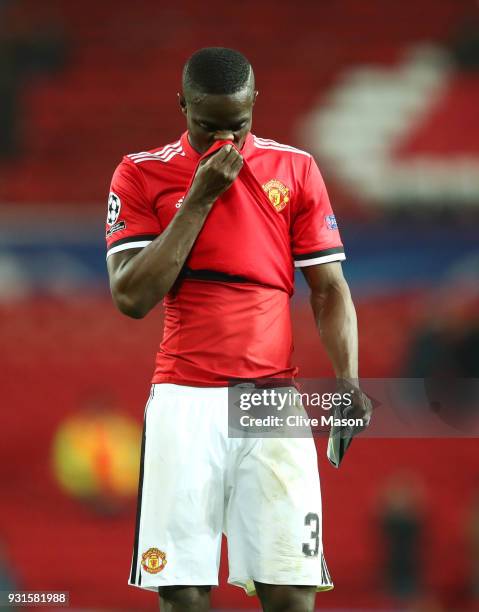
[0,0,479,611]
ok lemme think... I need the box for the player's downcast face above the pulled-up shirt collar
[180,86,257,153]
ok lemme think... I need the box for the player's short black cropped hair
[183,47,252,95]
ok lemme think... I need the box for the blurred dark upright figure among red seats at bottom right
[380,474,423,600]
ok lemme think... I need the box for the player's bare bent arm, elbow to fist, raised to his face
[107,145,243,318]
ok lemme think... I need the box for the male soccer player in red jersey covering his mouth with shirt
[106,48,370,612]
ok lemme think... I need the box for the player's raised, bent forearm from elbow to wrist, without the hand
[110,193,214,318]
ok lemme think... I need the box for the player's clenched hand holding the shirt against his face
[191,145,243,202]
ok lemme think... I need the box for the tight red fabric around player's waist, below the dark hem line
[158,280,297,386]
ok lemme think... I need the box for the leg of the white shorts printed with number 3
[226,438,332,591]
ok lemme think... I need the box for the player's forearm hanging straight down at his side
[311,281,358,380]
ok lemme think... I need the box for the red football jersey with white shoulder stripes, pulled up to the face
[106,132,345,386]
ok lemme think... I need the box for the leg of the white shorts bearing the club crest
[130,385,229,589]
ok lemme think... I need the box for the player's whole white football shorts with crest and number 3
[129,384,333,595]
